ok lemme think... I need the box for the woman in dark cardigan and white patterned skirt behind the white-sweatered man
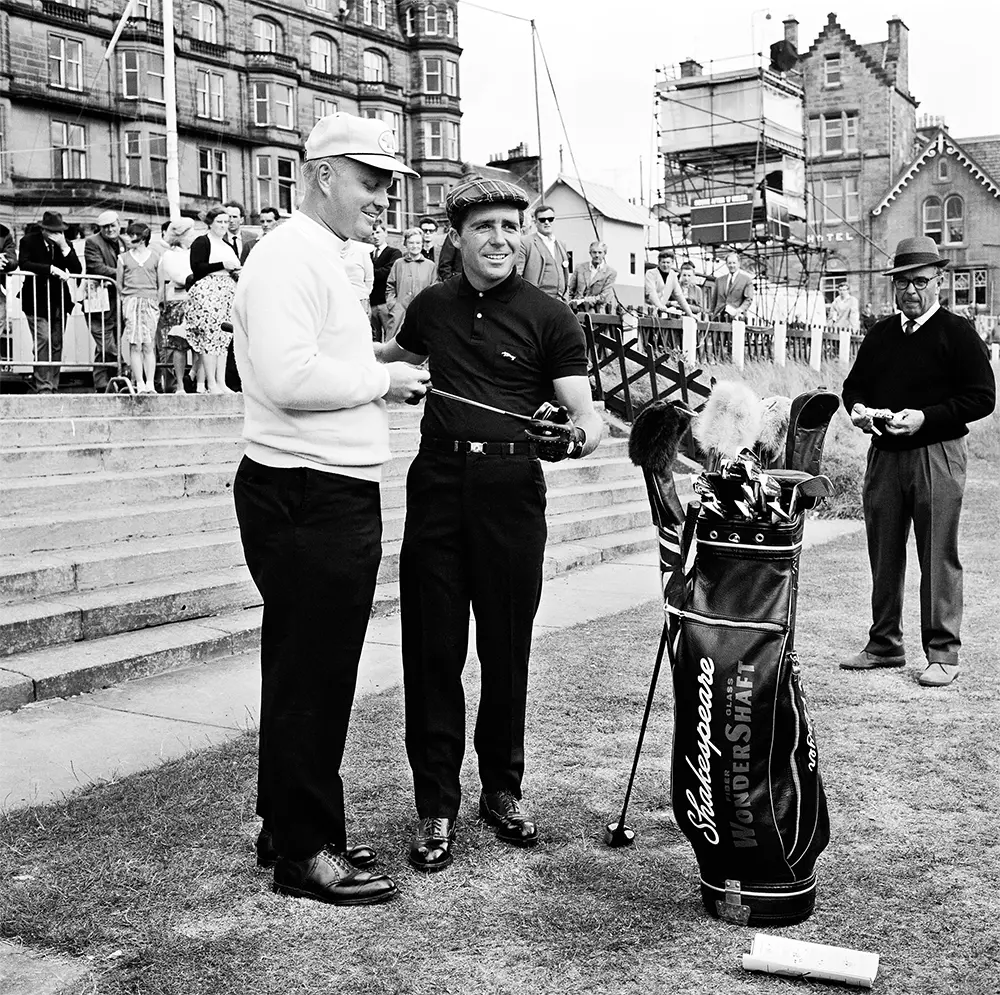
[185,204,240,394]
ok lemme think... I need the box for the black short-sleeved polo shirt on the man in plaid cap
[396,271,587,442]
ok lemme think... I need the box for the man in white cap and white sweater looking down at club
[233,114,429,905]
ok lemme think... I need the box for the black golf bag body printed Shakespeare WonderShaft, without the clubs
[666,515,830,926]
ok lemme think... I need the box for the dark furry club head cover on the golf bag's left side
[628,400,692,530]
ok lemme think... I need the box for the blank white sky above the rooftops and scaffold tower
[459,0,1000,197]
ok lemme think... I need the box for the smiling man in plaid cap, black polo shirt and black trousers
[381,179,603,871]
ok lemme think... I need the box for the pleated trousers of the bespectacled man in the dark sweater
[863,438,968,664]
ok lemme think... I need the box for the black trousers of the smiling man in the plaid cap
[399,452,546,818]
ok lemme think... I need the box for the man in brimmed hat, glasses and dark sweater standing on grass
[840,236,996,687]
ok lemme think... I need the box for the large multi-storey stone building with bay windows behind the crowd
[0,0,461,231]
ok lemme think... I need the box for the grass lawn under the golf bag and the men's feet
[0,461,1000,995]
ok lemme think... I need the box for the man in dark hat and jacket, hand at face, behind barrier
[17,211,83,391]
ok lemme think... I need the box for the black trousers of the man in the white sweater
[233,457,382,859]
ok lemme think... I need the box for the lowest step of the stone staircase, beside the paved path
[0,526,656,712]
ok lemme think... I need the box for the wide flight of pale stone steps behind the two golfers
[0,395,655,711]
